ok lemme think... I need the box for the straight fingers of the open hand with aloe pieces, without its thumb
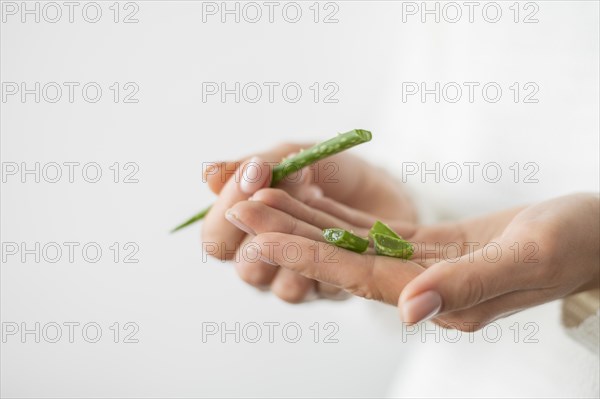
[229,188,424,305]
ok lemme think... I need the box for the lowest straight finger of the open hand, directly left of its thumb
[249,233,423,304]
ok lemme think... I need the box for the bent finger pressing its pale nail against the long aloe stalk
[202,157,271,259]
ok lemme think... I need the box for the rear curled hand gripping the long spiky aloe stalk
[202,144,416,303]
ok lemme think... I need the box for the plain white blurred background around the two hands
[0,1,599,397]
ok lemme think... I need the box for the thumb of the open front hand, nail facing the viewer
[398,242,531,323]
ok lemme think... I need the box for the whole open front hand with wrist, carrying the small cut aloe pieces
[233,189,600,331]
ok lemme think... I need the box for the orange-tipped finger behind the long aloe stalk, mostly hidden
[203,143,304,194]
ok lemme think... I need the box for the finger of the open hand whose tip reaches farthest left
[226,201,324,241]
